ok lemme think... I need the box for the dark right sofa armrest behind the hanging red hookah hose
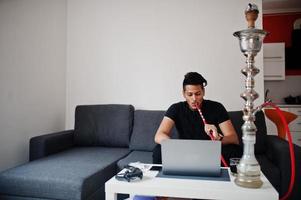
[267,135,301,199]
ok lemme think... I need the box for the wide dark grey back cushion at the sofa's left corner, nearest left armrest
[74,105,134,147]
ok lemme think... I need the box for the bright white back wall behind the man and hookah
[66,0,263,127]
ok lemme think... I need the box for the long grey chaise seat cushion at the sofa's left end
[0,147,129,200]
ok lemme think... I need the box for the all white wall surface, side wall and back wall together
[0,0,263,171]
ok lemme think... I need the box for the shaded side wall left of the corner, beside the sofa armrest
[0,0,66,171]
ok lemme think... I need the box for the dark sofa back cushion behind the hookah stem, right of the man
[229,111,267,154]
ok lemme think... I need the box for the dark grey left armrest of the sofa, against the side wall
[29,130,74,161]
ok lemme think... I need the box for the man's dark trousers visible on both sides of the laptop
[153,144,242,165]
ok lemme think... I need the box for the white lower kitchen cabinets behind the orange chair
[266,105,301,147]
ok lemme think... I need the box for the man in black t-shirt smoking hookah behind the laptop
[153,72,242,163]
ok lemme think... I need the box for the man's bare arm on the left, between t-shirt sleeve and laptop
[155,117,175,144]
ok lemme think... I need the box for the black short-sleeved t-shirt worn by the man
[165,100,229,140]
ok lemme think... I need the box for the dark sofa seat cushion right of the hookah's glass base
[256,155,281,192]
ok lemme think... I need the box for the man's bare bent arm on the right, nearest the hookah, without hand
[219,120,239,144]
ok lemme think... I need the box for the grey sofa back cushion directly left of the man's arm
[130,110,177,151]
